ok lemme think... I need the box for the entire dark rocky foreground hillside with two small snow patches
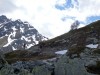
[0,20,100,75]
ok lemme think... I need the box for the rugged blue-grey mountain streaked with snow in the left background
[0,15,48,52]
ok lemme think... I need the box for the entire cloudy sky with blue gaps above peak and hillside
[0,0,100,38]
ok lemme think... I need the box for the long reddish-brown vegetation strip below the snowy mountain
[5,50,56,64]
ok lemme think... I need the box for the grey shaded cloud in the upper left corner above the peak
[0,0,16,14]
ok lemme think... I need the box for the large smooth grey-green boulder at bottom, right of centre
[55,56,93,75]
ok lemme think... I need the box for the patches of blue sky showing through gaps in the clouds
[55,0,100,24]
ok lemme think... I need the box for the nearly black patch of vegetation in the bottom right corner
[86,61,100,74]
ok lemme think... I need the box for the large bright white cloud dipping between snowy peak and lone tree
[4,0,73,38]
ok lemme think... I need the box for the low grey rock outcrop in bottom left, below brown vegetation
[0,61,52,75]
